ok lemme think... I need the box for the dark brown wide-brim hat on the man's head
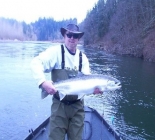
[60,24,84,38]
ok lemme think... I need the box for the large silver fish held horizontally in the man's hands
[41,74,121,100]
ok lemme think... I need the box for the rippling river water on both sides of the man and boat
[0,42,155,140]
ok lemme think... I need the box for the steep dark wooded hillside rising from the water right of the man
[81,0,155,62]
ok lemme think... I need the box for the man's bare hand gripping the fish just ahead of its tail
[41,81,57,95]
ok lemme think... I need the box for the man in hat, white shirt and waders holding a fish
[31,24,101,140]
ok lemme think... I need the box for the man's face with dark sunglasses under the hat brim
[64,31,79,49]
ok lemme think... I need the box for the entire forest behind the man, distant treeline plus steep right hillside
[0,0,155,62]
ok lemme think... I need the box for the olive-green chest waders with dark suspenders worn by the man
[49,45,85,140]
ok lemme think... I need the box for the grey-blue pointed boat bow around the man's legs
[24,106,121,140]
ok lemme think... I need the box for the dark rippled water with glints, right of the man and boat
[85,48,155,140]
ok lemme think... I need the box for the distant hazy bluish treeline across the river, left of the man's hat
[0,18,77,41]
